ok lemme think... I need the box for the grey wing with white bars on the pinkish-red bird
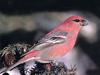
[33,31,68,50]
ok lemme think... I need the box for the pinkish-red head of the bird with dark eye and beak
[66,16,88,27]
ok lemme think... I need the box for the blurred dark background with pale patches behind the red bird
[0,0,100,75]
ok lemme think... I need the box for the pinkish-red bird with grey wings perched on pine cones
[0,16,88,73]
